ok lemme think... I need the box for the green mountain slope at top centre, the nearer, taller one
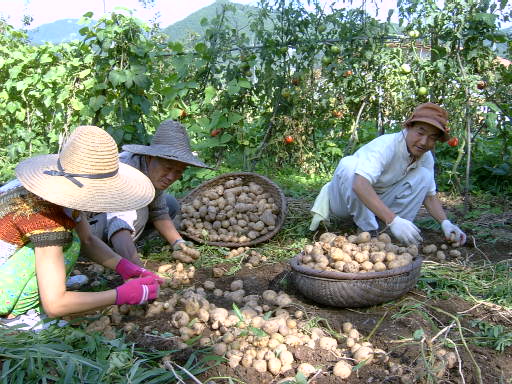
[163,0,257,42]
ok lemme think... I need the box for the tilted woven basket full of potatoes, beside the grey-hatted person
[179,172,287,247]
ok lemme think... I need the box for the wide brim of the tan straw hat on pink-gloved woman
[16,155,155,212]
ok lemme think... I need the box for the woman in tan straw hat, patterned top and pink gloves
[0,126,161,330]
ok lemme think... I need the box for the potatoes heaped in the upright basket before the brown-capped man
[299,232,418,273]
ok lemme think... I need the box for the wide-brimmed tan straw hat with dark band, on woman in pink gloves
[16,126,155,212]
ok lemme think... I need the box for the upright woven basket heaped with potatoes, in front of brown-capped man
[290,232,423,307]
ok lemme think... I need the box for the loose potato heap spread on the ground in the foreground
[101,280,388,378]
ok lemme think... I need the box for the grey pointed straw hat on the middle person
[123,120,211,169]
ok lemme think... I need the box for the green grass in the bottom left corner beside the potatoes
[0,327,214,384]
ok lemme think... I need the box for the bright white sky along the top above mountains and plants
[0,0,396,28]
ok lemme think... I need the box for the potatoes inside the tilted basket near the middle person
[181,177,279,243]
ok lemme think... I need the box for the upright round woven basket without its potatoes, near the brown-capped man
[290,254,423,308]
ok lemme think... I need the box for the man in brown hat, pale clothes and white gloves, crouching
[310,103,466,245]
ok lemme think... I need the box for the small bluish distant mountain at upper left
[27,19,89,44]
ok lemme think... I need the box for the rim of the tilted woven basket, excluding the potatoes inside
[178,172,287,248]
